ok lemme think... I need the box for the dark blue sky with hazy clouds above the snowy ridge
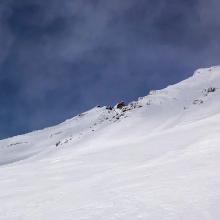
[0,0,220,139]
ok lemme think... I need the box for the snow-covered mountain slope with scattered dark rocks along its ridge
[0,67,220,220]
